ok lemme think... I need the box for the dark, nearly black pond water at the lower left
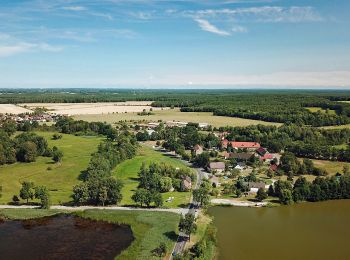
[0,215,134,260]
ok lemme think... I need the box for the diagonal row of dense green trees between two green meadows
[72,133,137,206]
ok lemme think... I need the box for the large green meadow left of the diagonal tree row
[0,132,102,204]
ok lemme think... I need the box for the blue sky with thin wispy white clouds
[0,0,350,88]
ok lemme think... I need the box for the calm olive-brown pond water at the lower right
[209,200,350,260]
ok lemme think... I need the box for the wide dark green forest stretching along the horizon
[0,89,350,126]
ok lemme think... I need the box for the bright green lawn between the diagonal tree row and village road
[113,145,191,208]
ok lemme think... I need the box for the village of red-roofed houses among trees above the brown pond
[131,121,281,206]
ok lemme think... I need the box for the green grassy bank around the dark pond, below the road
[0,209,180,259]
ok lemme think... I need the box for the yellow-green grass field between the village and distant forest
[74,109,281,127]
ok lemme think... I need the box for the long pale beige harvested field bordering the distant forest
[21,101,164,116]
